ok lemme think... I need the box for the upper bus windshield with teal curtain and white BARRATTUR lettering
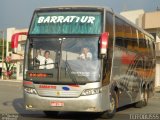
[29,11,102,35]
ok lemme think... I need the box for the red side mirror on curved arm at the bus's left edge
[11,32,28,54]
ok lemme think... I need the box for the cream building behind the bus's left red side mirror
[6,28,28,80]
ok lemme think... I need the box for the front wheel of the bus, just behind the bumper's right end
[101,92,118,119]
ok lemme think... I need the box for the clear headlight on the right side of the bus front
[81,88,102,96]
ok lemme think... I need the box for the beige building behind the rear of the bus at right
[120,10,160,87]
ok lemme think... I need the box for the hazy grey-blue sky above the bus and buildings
[0,0,160,30]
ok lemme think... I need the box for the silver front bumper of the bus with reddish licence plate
[24,93,109,112]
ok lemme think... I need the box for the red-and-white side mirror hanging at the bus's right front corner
[100,32,109,55]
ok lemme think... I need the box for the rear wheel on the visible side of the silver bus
[135,89,149,108]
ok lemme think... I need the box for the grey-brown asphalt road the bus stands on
[0,80,160,120]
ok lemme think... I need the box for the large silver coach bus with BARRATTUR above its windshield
[12,7,155,118]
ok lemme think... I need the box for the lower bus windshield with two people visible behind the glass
[29,37,100,83]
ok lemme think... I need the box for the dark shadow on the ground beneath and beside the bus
[12,98,133,120]
